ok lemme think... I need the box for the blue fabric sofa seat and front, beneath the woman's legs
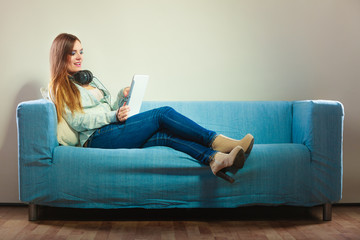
[29,144,316,208]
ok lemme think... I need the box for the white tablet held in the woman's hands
[126,75,149,117]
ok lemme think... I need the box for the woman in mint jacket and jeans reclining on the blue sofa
[49,33,254,182]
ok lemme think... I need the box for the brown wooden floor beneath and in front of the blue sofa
[0,205,360,240]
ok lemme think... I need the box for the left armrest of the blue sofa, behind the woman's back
[16,99,59,202]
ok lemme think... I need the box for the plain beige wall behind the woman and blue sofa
[0,0,360,203]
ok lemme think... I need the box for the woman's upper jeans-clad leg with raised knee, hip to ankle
[88,107,216,148]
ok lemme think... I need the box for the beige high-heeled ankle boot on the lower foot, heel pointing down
[210,146,245,183]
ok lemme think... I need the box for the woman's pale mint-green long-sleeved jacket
[63,77,125,146]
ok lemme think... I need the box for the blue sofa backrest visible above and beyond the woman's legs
[141,101,292,144]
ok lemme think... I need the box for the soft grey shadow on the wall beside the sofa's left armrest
[0,81,41,203]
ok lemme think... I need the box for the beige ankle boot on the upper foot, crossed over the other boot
[211,134,254,154]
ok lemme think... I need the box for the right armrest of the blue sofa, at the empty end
[292,100,344,202]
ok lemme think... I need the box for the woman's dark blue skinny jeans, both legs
[87,107,217,164]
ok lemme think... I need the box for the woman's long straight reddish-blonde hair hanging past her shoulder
[49,33,82,121]
